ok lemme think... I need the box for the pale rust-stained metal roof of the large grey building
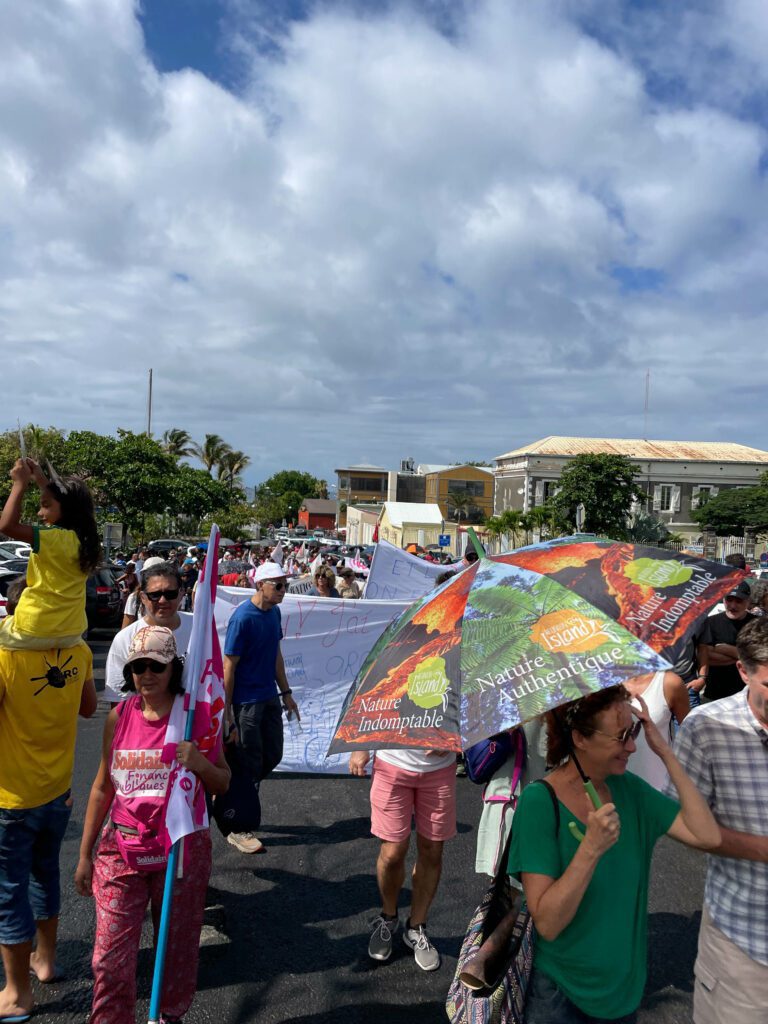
[495,435,768,464]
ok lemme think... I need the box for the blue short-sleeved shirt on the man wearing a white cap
[224,601,283,703]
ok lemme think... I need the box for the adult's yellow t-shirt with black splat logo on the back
[0,644,93,809]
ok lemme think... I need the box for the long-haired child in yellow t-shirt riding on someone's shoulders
[0,459,101,650]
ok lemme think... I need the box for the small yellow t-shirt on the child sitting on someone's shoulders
[13,526,88,637]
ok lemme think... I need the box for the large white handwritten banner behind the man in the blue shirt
[215,589,410,774]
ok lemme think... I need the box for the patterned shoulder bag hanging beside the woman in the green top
[445,780,560,1024]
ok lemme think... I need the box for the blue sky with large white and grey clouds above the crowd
[0,0,768,483]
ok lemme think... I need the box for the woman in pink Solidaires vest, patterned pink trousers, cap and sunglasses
[75,626,229,1024]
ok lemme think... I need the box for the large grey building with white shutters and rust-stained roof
[494,436,768,537]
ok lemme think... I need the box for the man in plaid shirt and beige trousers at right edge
[675,617,768,1024]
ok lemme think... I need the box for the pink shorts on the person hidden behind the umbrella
[371,758,456,843]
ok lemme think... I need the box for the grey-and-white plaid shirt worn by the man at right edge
[668,687,768,966]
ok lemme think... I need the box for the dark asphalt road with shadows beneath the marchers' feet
[15,642,705,1024]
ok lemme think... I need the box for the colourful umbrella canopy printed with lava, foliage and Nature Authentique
[329,541,741,754]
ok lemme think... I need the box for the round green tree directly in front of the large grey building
[549,454,645,540]
